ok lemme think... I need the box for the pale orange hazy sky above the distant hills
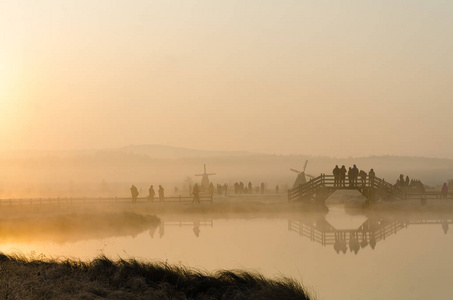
[0,0,453,158]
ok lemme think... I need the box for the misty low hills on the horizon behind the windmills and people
[0,151,453,197]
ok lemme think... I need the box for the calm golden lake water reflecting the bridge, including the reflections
[0,198,453,299]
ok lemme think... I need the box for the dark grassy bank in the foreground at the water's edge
[0,254,309,299]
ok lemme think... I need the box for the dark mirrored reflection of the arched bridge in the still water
[288,217,453,254]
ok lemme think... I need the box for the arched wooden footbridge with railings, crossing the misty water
[288,174,453,204]
